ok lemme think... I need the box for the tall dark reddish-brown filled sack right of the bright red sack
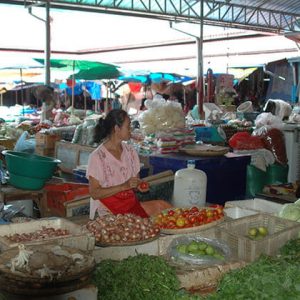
[260,128,288,165]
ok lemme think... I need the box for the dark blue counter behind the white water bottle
[149,153,251,204]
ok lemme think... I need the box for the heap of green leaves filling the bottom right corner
[205,239,300,300]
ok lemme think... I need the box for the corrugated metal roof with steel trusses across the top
[0,0,300,33]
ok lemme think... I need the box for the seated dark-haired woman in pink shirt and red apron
[86,109,171,218]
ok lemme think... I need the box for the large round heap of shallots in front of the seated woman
[86,214,160,244]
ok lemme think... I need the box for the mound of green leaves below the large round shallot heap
[94,254,179,300]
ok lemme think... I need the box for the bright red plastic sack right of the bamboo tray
[229,131,264,150]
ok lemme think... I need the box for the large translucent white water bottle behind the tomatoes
[172,160,207,207]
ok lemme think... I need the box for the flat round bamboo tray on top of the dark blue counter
[179,145,229,156]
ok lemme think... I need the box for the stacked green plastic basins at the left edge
[3,150,61,190]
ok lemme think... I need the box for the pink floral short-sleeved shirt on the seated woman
[86,142,140,187]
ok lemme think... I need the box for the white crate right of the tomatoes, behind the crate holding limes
[225,198,283,215]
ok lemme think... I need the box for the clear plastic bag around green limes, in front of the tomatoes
[167,236,231,266]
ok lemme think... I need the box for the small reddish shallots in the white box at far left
[5,226,70,243]
